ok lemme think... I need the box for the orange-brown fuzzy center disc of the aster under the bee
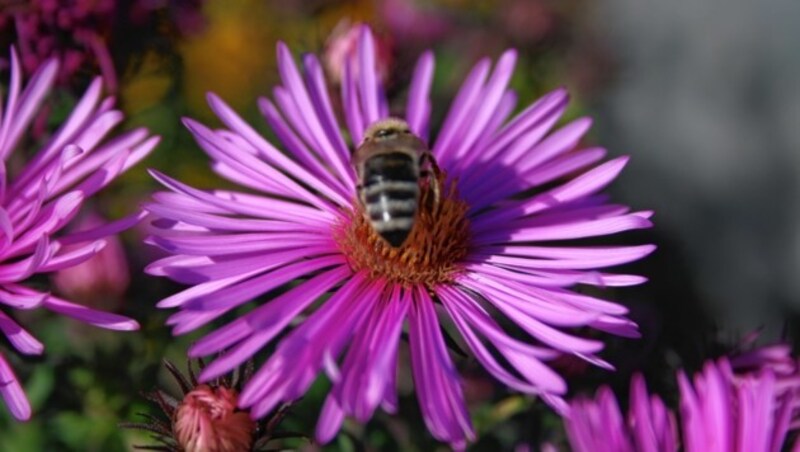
[336,174,469,288]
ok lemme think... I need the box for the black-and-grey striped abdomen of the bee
[360,152,419,247]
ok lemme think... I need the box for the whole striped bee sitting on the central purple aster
[353,118,440,248]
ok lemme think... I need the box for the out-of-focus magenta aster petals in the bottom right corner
[566,356,800,452]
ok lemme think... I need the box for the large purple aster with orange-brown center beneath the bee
[147,28,653,446]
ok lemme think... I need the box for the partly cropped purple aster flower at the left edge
[0,51,158,419]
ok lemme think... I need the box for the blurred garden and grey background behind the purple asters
[0,0,800,451]
